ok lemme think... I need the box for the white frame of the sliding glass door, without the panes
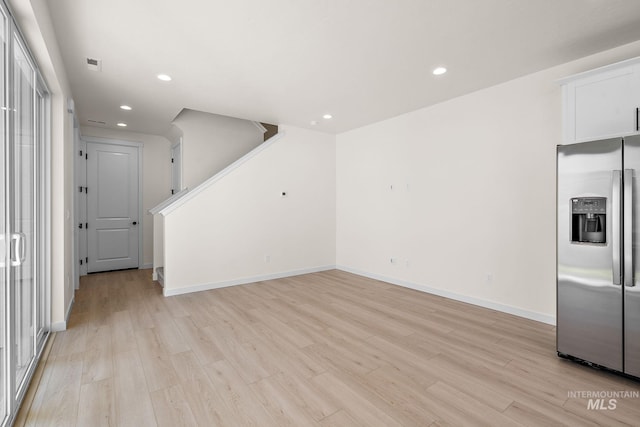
[0,1,51,427]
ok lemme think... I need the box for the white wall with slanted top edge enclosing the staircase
[164,126,336,295]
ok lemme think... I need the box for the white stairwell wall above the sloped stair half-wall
[172,109,263,188]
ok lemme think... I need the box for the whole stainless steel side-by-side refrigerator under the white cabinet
[557,136,640,377]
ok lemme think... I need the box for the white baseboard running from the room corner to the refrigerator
[336,265,556,326]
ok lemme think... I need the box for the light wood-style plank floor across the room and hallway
[13,270,640,427]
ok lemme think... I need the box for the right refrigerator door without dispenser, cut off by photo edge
[624,136,640,377]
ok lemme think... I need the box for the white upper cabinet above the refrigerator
[561,60,640,144]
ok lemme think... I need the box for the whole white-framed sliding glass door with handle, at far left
[0,5,49,426]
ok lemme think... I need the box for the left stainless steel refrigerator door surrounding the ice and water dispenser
[557,139,623,371]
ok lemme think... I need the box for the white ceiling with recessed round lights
[49,0,640,134]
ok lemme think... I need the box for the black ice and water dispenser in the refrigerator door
[571,197,607,244]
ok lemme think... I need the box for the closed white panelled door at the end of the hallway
[87,142,141,273]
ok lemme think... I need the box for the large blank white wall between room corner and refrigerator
[336,39,640,323]
